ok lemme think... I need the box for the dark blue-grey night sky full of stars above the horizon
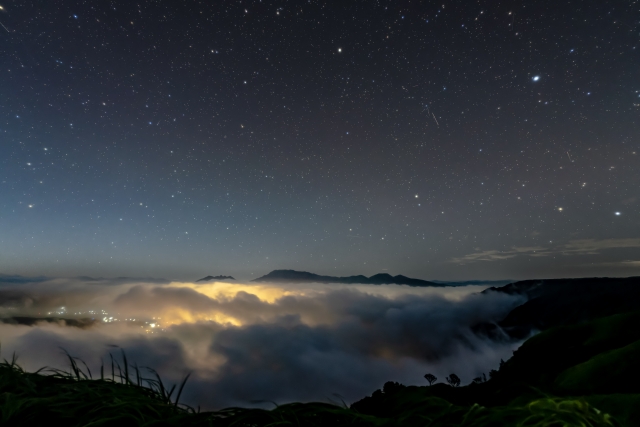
[0,0,640,280]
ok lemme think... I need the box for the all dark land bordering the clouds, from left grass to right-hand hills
[0,278,640,427]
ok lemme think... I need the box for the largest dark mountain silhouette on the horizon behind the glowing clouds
[252,270,447,287]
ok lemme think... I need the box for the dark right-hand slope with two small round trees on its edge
[351,311,640,426]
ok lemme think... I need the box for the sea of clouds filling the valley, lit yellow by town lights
[0,276,523,409]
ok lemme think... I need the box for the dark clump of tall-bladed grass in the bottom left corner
[0,352,206,427]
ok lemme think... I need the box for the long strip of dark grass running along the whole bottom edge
[0,355,620,427]
